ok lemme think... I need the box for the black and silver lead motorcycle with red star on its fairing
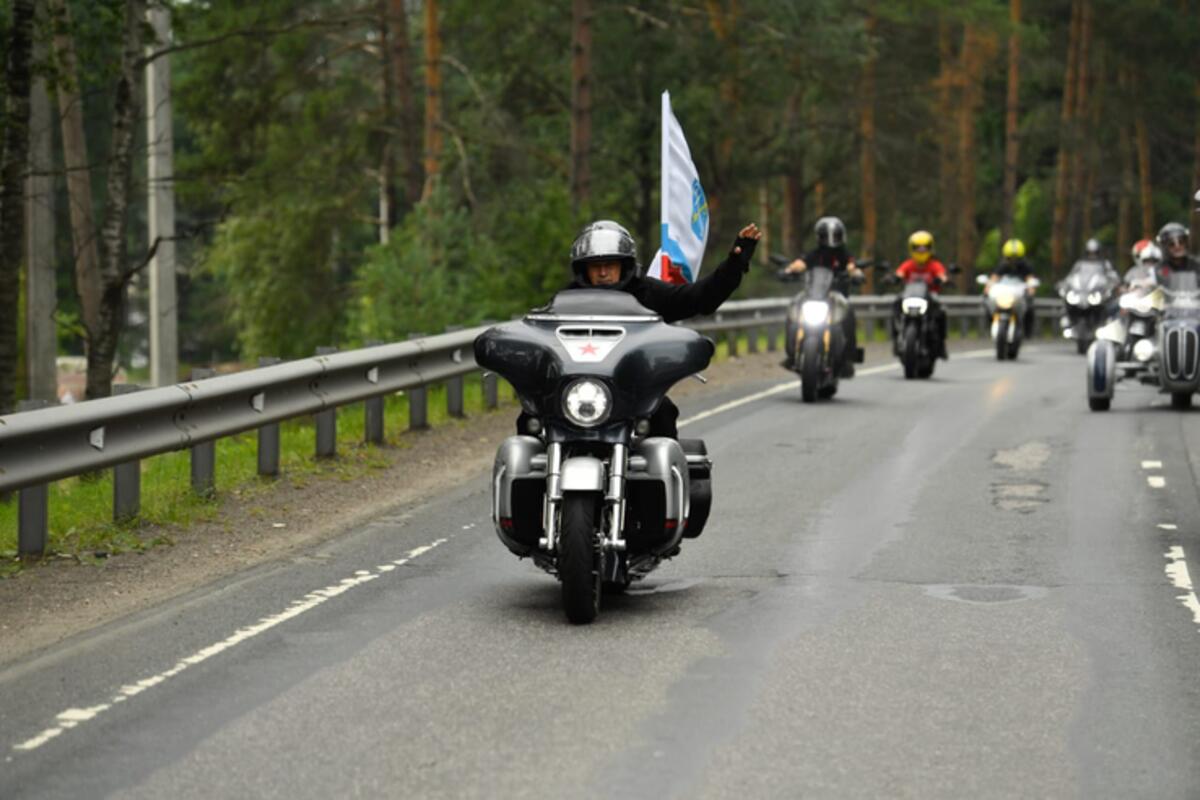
[475,289,714,624]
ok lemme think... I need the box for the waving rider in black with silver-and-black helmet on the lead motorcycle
[517,219,762,439]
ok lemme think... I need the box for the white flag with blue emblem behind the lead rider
[647,91,708,283]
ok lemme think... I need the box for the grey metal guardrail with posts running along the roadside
[0,295,1061,555]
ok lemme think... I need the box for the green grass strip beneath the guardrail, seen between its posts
[0,374,515,568]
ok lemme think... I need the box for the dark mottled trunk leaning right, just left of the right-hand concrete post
[86,0,146,399]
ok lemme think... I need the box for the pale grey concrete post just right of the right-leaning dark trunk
[146,4,179,386]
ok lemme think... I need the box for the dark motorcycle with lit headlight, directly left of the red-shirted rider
[775,259,864,403]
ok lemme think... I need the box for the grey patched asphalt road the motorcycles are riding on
[0,344,1200,800]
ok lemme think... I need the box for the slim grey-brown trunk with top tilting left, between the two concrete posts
[53,0,101,337]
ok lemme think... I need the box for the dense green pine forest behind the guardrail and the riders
[0,0,1200,413]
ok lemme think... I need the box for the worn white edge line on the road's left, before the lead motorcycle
[12,539,449,752]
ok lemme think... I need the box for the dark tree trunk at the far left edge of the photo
[0,0,34,414]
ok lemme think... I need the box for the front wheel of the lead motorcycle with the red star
[558,492,601,625]
